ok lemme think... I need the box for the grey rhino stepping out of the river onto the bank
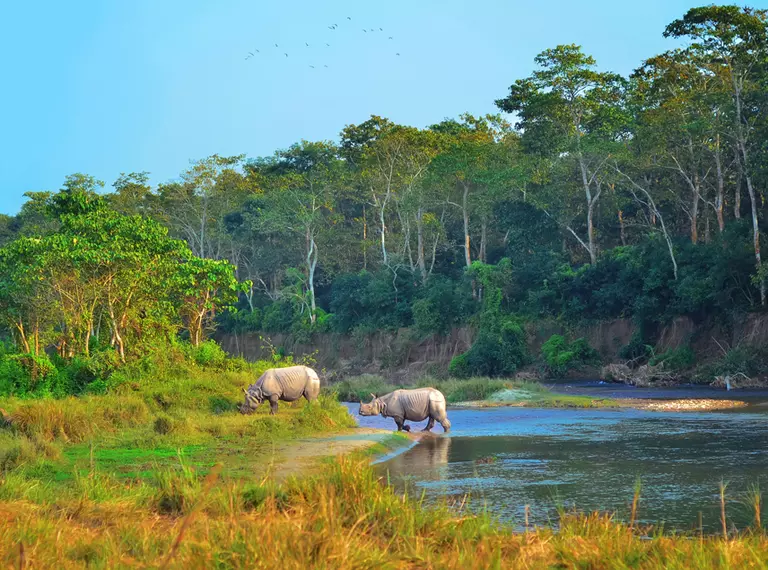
[358,388,451,432]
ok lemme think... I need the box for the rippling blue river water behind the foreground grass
[348,391,768,531]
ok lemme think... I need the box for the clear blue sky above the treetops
[0,0,752,214]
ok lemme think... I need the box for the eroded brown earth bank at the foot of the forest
[215,314,768,384]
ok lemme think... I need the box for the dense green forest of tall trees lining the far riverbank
[0,6,768,382]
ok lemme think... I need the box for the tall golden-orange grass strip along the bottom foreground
[0,458,768,569]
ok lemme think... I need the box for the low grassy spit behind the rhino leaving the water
[329,374,618,408]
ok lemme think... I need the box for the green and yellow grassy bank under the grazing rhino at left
[0,356,354,484]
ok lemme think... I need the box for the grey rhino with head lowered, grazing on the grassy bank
[240,366,320,415]
